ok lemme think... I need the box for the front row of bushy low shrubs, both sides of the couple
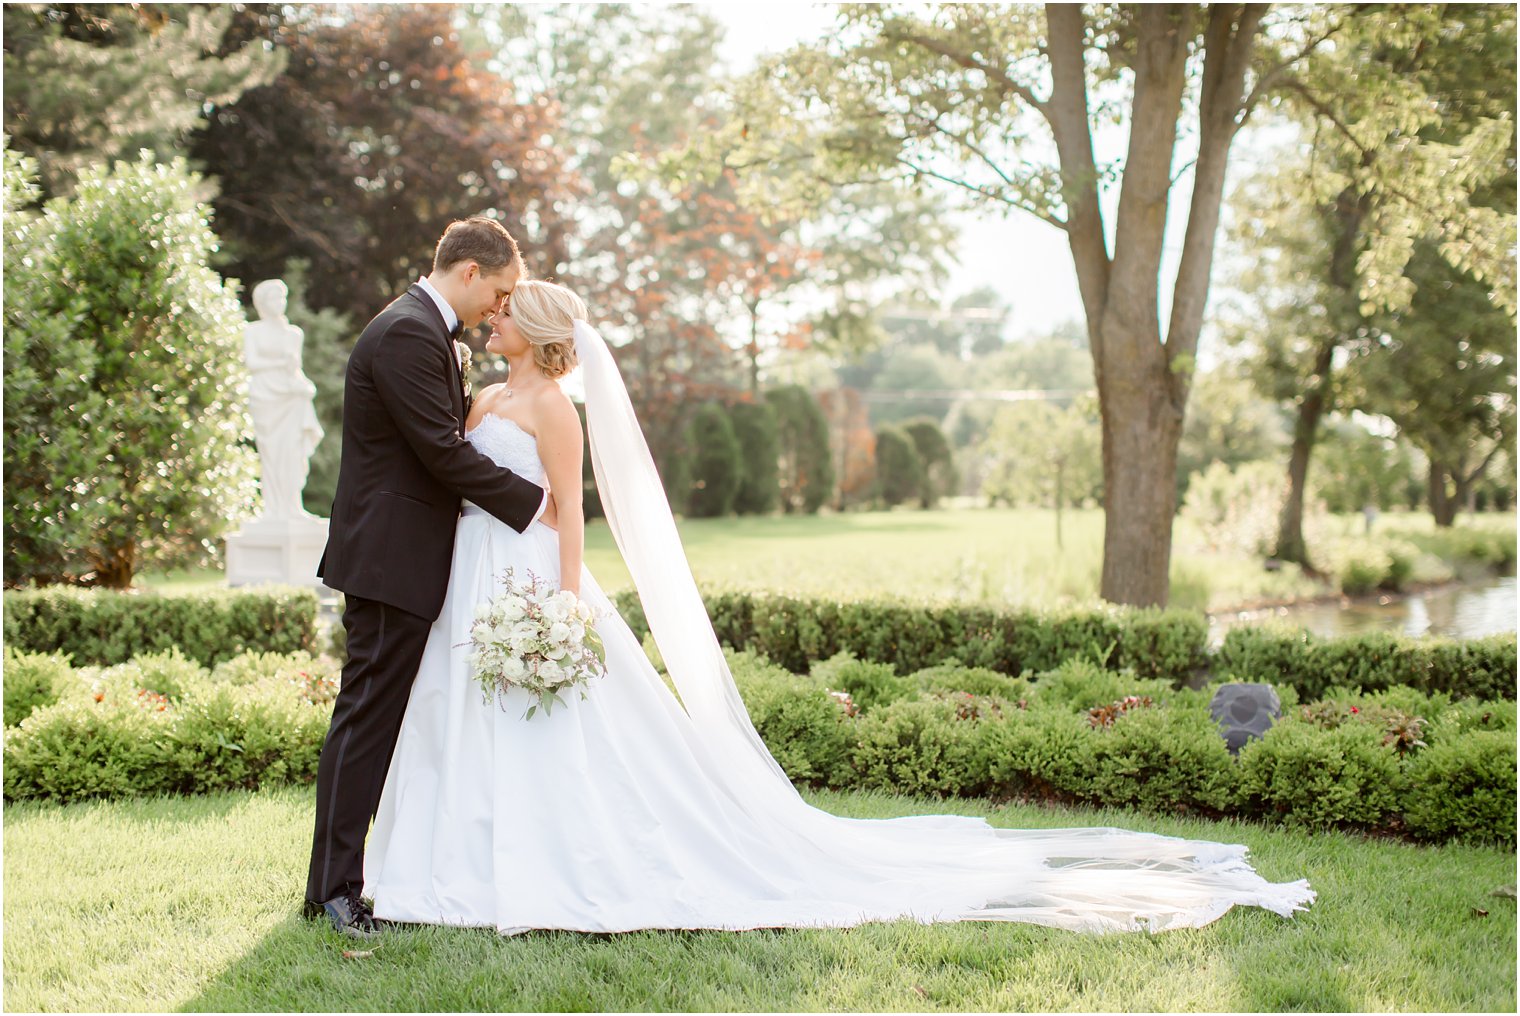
[5,651,1515,844]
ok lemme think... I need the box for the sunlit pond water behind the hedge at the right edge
[1208,575,1520,643]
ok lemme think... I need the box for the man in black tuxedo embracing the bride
[306,217,553,937]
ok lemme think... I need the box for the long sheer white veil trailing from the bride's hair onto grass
[575,321,1315,931]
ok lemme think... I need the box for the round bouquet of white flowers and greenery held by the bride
[462,569,606,719]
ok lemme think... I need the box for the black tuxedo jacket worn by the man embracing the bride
[316,286,544,618]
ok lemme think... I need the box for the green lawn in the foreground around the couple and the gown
[5,788,1515,1011]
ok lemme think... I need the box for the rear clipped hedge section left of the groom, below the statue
[5,587,318,666]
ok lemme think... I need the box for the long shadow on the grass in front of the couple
[174,910,1359,1011]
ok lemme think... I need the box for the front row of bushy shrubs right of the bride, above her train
[734,654,1515,844]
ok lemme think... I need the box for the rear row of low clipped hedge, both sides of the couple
[5,589,1515,700]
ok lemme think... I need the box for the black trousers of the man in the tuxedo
[306,596,433,903]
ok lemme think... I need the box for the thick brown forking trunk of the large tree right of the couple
[1038,3,1266,607]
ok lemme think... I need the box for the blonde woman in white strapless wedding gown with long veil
[365,281,1315,934]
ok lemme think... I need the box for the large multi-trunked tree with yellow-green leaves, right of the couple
[687,5,1500,604]
